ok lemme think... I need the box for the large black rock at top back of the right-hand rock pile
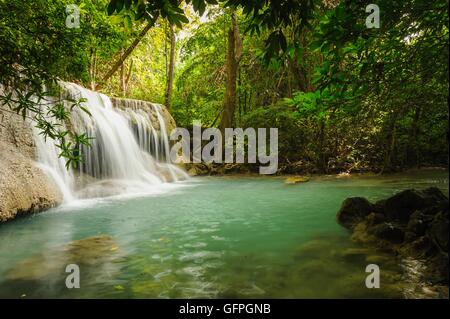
[384,187,446,223]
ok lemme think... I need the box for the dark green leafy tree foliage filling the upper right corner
[315,1,449,169]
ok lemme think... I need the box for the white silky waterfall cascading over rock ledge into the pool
[33,83,188,202]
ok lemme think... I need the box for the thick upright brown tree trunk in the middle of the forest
[220,13,242,134]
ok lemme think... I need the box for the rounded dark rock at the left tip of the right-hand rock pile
[337,197,373,229]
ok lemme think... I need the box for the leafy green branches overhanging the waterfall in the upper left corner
[0,0,133,165]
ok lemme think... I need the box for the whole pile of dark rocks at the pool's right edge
[337,187,449,285]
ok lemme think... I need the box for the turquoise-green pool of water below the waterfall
[0,171,448,298]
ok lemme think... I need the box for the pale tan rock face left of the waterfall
[0,110,62,222]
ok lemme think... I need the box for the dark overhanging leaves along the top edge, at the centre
[108,0,315,61]
